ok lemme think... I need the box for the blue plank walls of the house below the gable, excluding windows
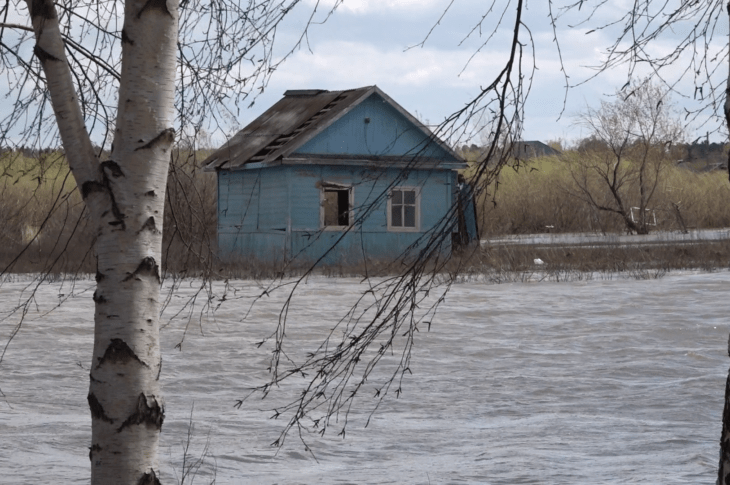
[218,165,456,264]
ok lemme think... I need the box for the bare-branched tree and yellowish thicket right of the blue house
[462,80,730,234]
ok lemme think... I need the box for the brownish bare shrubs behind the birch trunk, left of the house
[0,150,216,274]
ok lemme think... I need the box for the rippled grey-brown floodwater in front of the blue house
[0,272,730,484]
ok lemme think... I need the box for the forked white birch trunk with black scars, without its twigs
[26,0,178,485]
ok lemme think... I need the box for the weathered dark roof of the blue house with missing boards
[203,86,462,171]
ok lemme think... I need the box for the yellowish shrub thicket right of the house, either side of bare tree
[478,150,730,236]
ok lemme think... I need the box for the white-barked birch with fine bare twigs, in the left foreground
[0,0,330,485]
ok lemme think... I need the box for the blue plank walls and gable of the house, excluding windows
[218,93,460,264]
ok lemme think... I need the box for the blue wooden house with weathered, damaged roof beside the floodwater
[204,86,477,264]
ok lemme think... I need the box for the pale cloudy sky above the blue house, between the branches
[0,0,728,145]
